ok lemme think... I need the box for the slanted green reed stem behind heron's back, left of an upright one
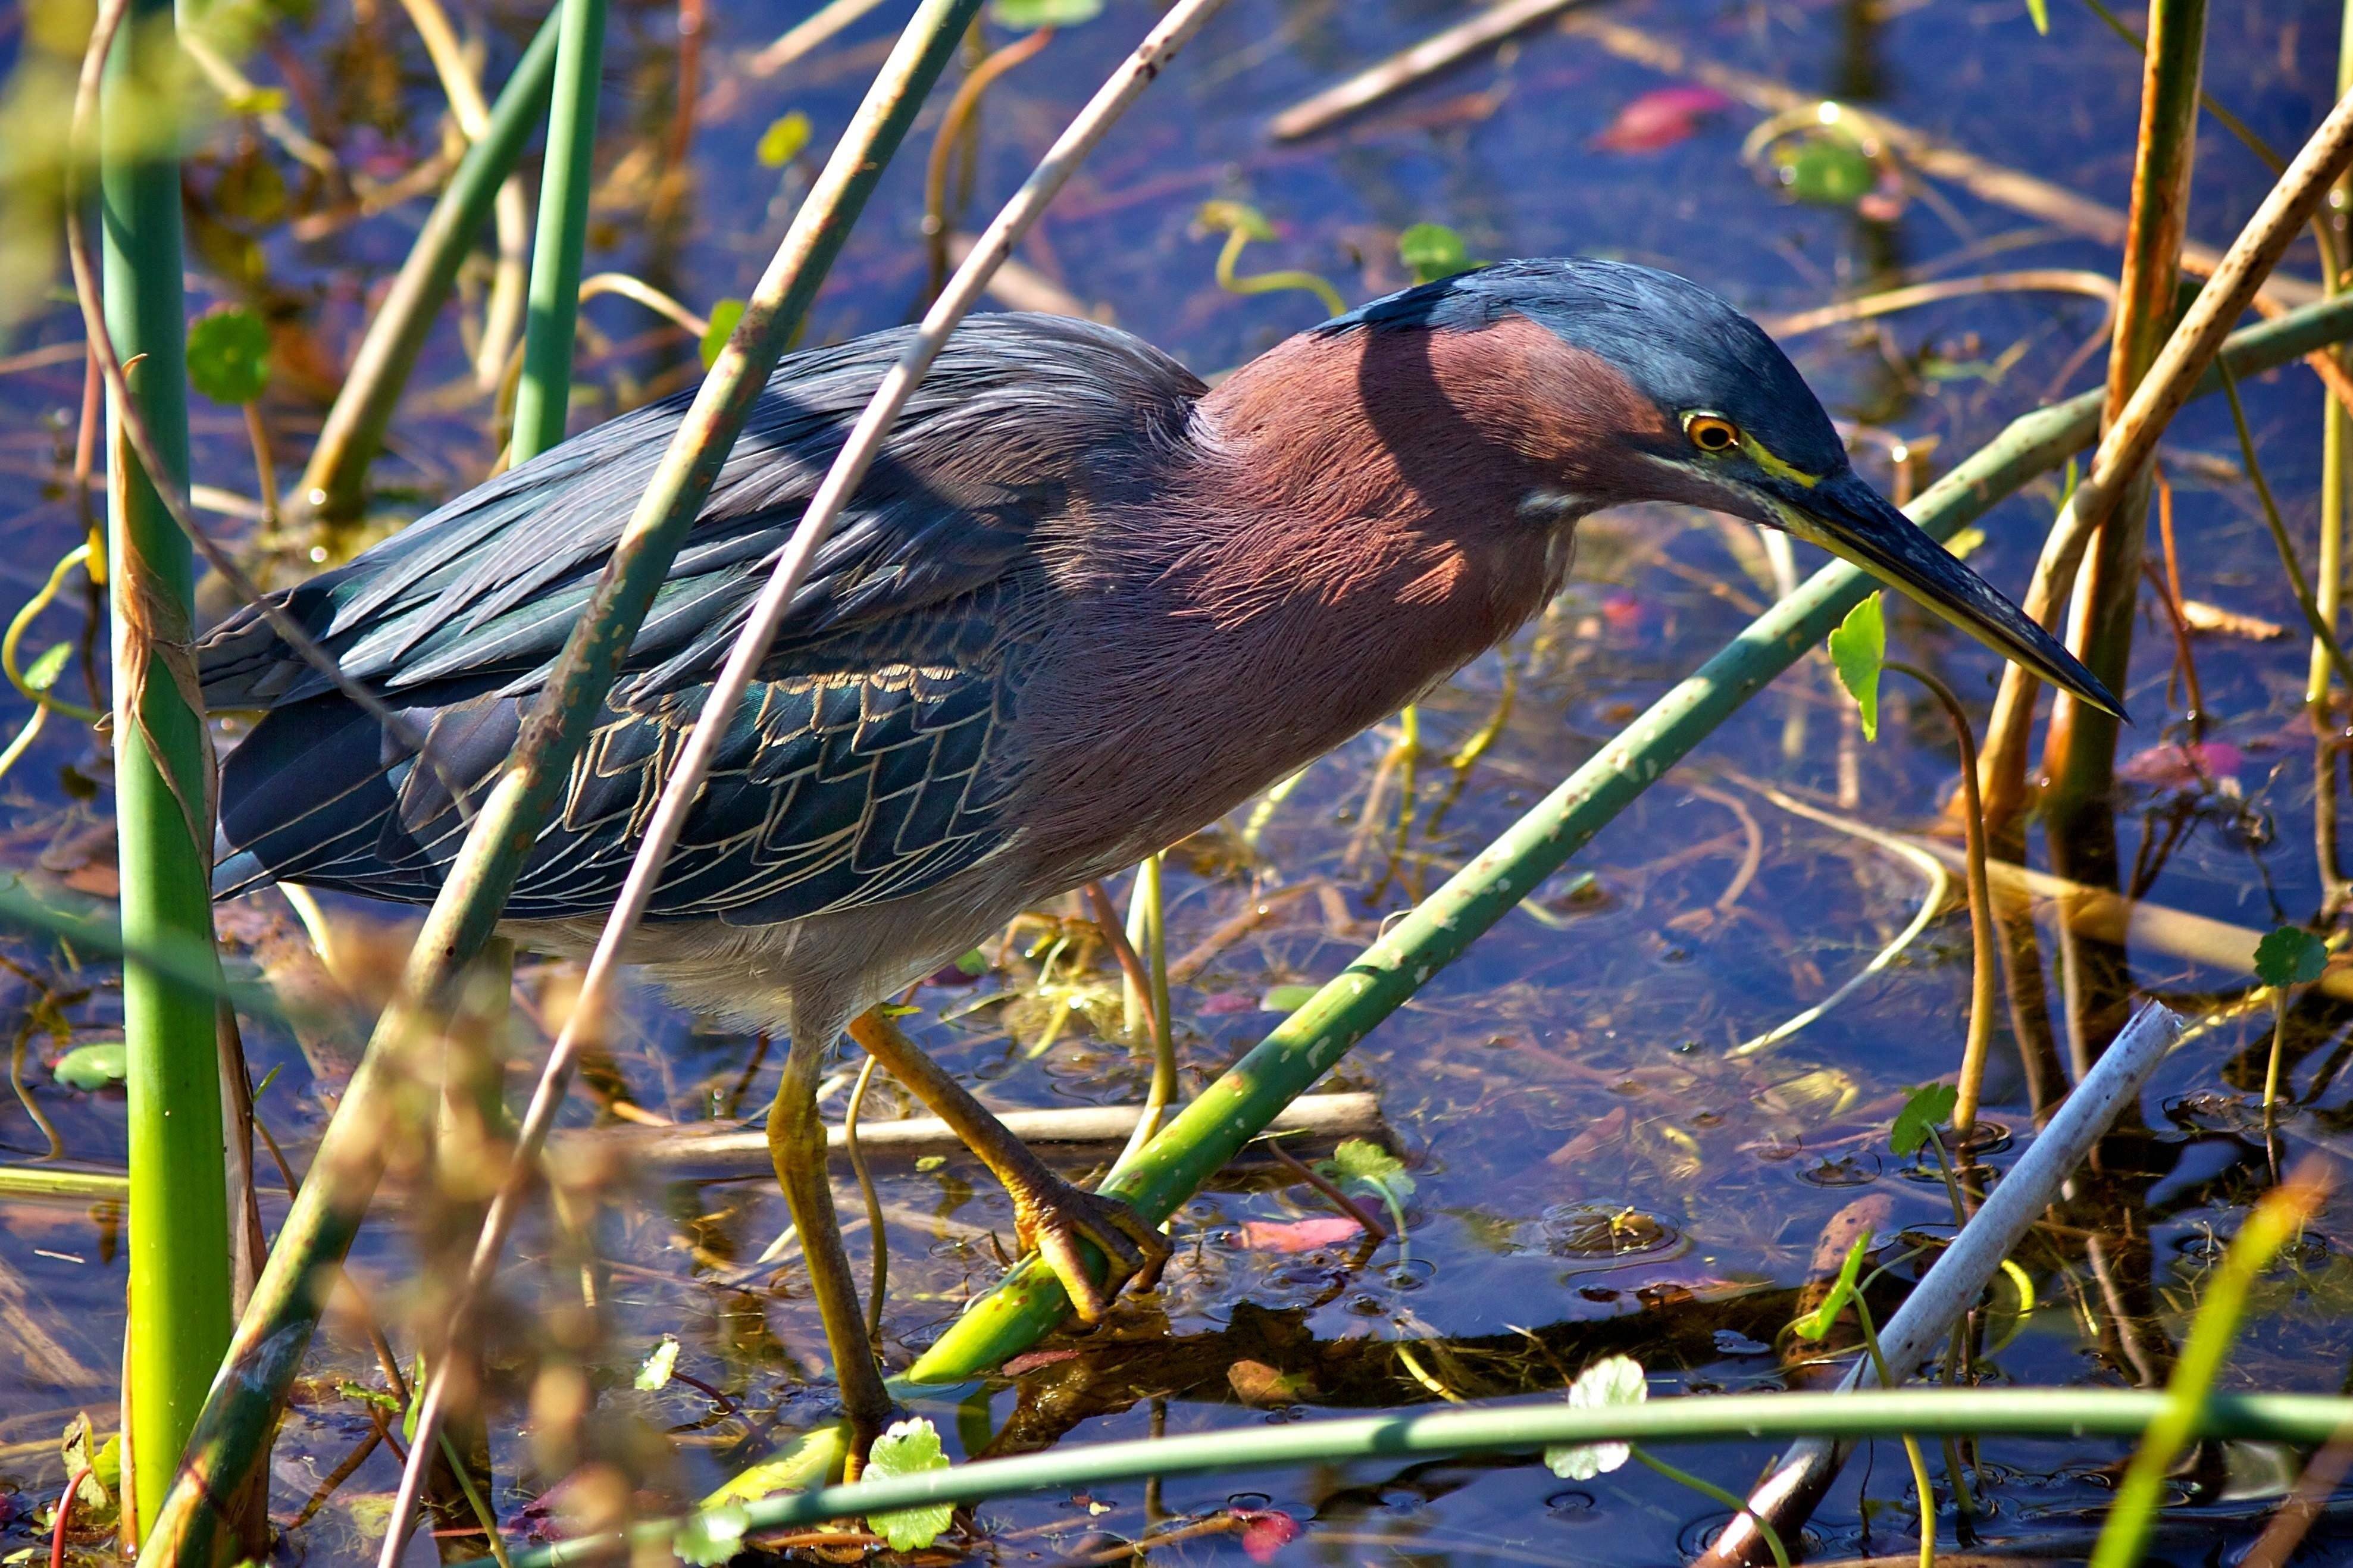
[284,17,560,522]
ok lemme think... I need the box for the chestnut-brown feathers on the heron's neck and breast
[1021,318,1662,876]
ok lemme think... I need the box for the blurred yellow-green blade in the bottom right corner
[2092,1172,2323,1568]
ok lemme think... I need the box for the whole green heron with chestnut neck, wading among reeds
[200,261,2116,1420]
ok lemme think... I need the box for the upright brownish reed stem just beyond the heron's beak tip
[2042,0,2207,828]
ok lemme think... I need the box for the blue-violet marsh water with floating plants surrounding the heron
[0,0,2353,1563]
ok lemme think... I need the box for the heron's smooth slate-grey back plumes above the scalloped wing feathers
[198,315,1200,709]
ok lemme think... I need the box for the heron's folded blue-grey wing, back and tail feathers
[198,315,1200,923]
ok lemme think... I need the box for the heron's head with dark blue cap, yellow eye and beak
[1325,259,2123,713]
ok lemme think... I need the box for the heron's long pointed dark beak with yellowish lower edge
[1779,468,2127,718]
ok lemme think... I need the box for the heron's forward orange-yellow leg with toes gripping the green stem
[852,1007,1169,1323]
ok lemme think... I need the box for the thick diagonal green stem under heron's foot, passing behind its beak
[906,281,2353,1382]
